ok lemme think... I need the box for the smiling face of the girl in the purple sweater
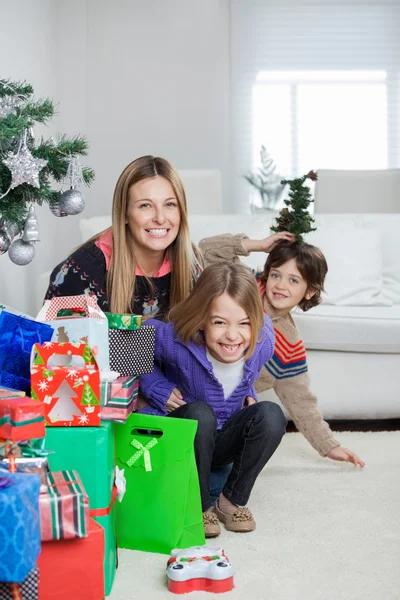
[203,292,251,363]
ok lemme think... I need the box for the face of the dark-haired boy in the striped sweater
[265,258,315,317]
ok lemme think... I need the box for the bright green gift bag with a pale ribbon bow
[115,413,205,554]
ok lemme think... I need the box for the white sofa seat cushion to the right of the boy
[292,304,400,353]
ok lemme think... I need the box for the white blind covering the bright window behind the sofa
[231,0,400,212]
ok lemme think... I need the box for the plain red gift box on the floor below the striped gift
[38,519,104,600]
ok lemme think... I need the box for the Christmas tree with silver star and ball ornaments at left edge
[0,80,94,265]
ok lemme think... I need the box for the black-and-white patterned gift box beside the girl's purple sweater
[108,325,155,375]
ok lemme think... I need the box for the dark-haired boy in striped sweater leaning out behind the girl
[200,232,364,468]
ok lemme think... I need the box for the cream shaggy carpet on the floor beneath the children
[108,431,400,600]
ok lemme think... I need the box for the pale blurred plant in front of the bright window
[244,146,285,210]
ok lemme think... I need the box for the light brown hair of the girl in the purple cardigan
[169,263,264,358]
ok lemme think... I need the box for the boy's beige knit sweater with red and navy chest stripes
[200,234,340,456]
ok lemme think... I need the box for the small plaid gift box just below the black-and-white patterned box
[100,375,139,421]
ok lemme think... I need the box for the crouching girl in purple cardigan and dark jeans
[140,264,286,537]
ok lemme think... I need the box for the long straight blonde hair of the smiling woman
[103,156,202,313]
